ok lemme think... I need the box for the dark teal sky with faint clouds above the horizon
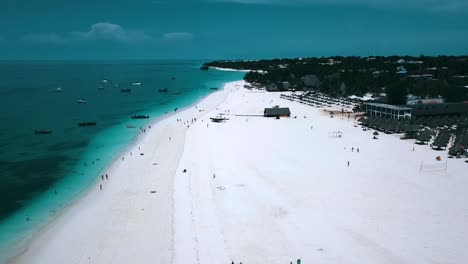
[0,0,468,60]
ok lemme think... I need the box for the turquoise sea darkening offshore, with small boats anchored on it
[0,61,244,262]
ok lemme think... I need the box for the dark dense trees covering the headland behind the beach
[202,56,468,104]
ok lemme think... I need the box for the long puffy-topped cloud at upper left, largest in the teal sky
[21,22,152,45]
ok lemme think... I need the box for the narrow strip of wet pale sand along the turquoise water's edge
[7,81,245,263]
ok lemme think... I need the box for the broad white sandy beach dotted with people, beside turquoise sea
[13,81,468,264]
